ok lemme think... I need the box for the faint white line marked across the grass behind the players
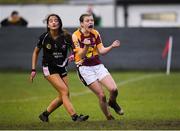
[0,74,163,103]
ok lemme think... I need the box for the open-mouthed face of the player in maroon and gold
[81,16,94,32]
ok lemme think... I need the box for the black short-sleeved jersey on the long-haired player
[37,32,72,67]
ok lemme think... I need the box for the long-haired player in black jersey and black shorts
[30,14,89,122]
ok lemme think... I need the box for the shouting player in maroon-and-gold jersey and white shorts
[72,14,123,120]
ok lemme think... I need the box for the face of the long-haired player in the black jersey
[48,16,59,30]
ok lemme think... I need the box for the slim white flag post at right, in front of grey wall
[166,36,173,75]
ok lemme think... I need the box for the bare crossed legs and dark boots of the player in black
[39,74,89,122]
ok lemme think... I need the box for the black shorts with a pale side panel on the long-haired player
[43,65,67,77]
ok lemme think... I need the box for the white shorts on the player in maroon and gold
[78,64,110,85]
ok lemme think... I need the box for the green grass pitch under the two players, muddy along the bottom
[0,72,180,130]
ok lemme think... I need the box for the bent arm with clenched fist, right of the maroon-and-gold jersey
[97,40,120,55]
